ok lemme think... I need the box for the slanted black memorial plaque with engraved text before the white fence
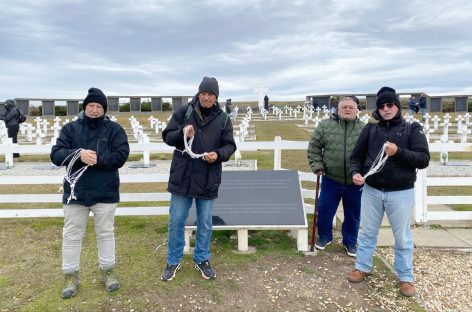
[185,170,306,228]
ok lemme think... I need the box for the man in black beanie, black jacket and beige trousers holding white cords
[50,88,129,299]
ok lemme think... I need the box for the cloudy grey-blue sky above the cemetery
[0,0,472,100]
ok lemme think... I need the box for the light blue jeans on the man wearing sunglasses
[356,184,415,282]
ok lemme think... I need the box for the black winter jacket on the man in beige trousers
[50,112,129,207]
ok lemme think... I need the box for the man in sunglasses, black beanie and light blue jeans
[348,87,430,297]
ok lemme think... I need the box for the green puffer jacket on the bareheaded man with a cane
[307,114,365,185]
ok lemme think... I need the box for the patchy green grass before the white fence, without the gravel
[0,216,421,311]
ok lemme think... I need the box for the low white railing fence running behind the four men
[0,137,472,223]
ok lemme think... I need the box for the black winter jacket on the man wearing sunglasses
[351,115,430,191]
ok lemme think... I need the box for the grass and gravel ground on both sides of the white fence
[0,114,472,312]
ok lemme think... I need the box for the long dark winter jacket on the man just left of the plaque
[162,97,236,199]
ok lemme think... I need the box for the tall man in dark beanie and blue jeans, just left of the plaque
[161,77,236,281]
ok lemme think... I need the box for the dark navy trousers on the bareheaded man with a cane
[316,176,362,246]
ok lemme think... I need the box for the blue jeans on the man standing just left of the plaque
[167,194,214,265]
